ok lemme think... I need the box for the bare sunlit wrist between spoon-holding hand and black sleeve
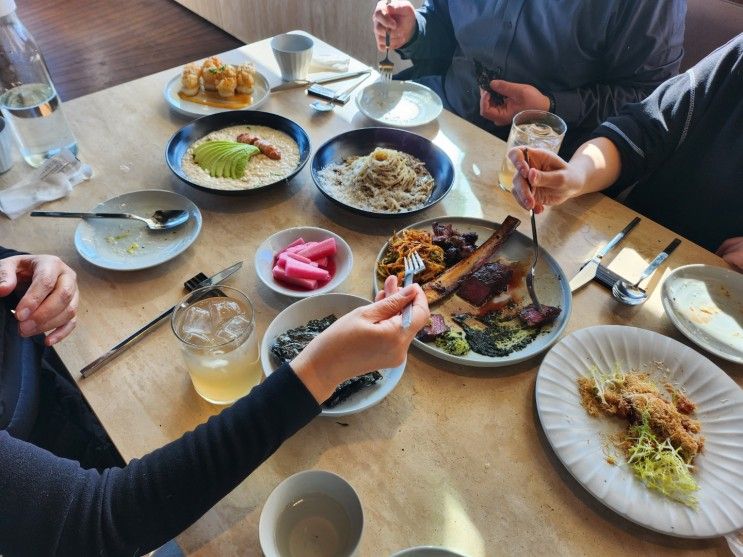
[568,137,622,197]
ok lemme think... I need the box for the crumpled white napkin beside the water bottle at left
[0,149,93,219]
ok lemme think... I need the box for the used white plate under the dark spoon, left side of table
[75,190,201,271]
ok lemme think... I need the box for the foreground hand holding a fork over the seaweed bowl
[291,276,429,403]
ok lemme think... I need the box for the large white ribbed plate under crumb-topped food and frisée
[535,325,743,538]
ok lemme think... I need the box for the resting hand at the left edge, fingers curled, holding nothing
[0,255,80,346]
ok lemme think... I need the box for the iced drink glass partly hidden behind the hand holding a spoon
[498,110,568,191]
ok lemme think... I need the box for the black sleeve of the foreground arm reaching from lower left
[0,365,320,557]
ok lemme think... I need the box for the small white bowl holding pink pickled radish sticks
[255,226,353,298]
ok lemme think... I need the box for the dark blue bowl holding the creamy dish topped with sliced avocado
[165,110,310,195]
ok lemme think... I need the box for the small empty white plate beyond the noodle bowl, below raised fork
[356,81,443,128]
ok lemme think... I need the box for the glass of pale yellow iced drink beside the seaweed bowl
[171,286,261,404]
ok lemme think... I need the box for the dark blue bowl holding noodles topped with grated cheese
[311,128,454,217]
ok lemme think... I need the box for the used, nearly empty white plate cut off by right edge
[661,265,743,364]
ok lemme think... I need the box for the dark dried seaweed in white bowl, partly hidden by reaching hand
[271,315,382,408]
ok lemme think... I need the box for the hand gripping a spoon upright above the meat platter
[506,147,583,214]
